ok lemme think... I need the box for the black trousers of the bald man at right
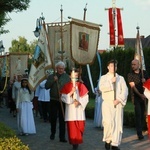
[134,99,145,136]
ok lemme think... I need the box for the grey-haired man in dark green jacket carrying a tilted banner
[45,61,70,142]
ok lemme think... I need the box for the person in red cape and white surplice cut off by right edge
[143,79,150,140]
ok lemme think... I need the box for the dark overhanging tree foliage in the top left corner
[0,0,30,34]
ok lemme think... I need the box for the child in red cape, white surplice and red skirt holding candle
[60,69,89,149]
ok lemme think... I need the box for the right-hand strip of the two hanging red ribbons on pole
[116,8,124,47]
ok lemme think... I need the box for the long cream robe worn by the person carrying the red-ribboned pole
[99,73,128,146]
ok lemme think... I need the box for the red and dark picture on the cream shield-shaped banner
[79,32,89,51]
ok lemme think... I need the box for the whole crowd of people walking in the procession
[0,59,150,150]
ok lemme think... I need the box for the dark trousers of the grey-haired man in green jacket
[50,100,65,139]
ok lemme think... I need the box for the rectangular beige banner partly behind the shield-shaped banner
[47,22,74,67]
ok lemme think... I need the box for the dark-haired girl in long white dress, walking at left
[16,78,36,135]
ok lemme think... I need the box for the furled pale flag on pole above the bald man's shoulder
[134,27,146,70]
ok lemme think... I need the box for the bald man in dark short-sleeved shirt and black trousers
[128,59,148,140]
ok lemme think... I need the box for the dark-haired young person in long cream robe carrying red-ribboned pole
[99,60,128,150]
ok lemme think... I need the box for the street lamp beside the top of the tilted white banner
[33,13,45,37]
